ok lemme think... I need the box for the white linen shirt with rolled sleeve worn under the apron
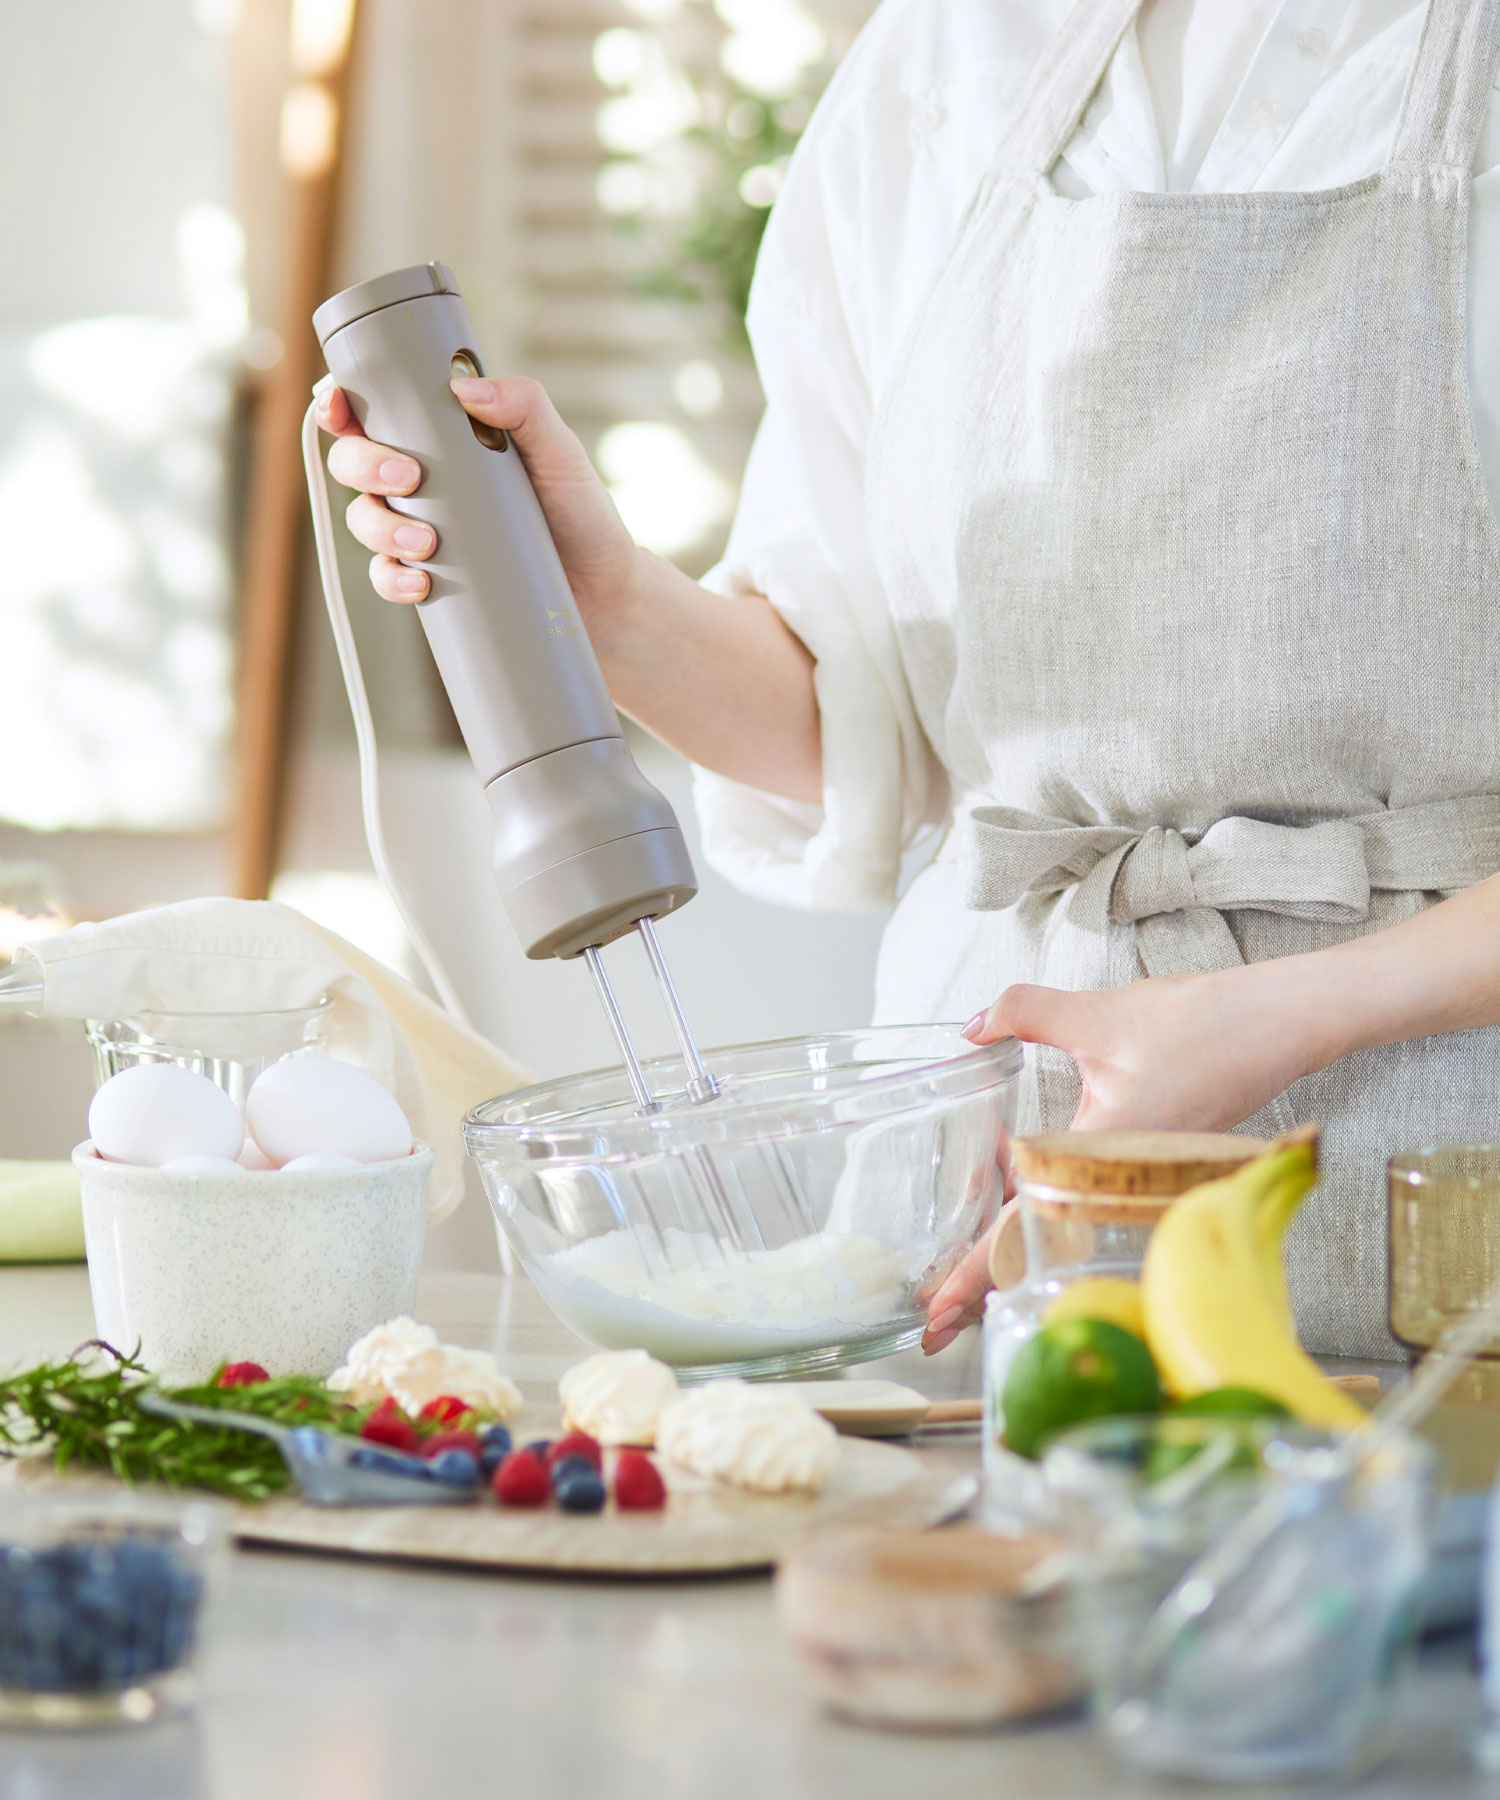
[695,0,1500,911]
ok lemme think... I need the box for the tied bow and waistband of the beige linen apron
[963,794,1500,976]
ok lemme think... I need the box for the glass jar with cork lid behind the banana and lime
[983,1130,1268,1523]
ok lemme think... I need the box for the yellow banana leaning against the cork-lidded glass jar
[1142,1132,1367,1429]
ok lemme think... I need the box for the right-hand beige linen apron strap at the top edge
[1387,0,1500,173]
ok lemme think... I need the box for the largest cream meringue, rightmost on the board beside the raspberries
[655,1381,839,1494]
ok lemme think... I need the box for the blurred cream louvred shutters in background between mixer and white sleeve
[513,0,872,572]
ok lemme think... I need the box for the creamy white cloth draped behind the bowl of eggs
[14,900,531,1220]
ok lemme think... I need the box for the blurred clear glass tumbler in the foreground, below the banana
[1044,1418,1435,1782]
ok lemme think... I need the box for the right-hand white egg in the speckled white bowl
[245,1057,412,1165]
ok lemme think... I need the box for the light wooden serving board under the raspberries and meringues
[11,1438,976,1575]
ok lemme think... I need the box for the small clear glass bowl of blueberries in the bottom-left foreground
[0,1489,225,1728]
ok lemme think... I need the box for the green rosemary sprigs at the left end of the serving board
[0,1339,364,1499]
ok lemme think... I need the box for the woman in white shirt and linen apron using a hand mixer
[324,0,1500,1355]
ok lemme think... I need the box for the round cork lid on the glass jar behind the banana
[1012,1130,1271,1201]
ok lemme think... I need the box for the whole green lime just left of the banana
[1001,1319,1161,1456]
